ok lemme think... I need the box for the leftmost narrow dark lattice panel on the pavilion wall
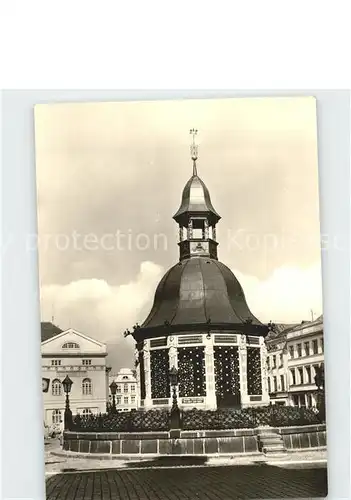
[150,349,171,399]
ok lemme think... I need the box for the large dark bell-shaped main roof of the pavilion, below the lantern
[135,257,267,340]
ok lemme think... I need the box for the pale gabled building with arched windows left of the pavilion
[41,322,109,427]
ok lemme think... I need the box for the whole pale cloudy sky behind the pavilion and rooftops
[35,97,322,370]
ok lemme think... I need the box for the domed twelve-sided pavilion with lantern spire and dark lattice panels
[129,139,269,409]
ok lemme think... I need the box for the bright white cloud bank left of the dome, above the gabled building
[41,262,163,366]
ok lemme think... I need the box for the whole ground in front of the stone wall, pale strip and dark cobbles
[45,441,327,500]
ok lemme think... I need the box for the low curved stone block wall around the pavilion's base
[63,425,326,457]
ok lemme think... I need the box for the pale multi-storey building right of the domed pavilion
[266,316,324,408]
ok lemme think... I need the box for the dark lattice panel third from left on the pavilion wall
[214,346,240,401]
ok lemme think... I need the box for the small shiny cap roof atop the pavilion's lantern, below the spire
[173,175,221,222]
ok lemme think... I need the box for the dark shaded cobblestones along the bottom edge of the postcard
[46,464,327,500]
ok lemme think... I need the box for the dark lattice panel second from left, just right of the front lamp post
[178,347,206,397]
